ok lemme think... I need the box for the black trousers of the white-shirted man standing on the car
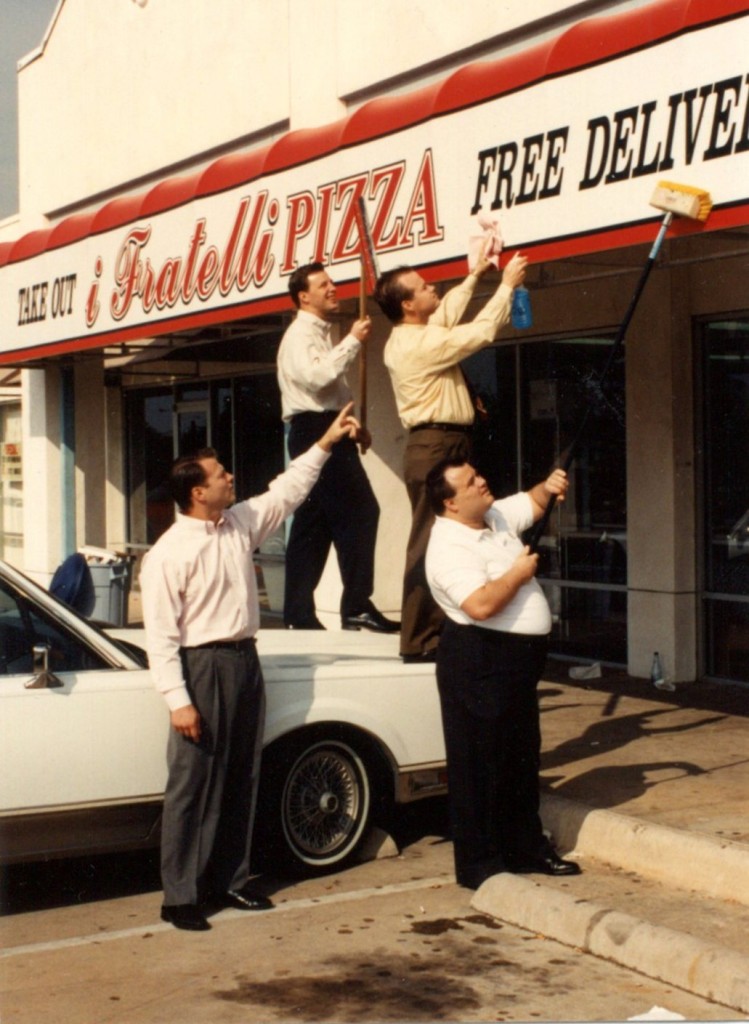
[284,412,380,627]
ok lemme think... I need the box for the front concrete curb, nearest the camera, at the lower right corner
[471,874,749,1013]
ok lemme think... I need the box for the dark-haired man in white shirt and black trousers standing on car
[278,263,401,633]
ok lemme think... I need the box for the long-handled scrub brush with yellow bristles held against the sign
[530,181,712,552]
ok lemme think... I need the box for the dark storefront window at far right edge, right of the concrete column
[703,319,749,682]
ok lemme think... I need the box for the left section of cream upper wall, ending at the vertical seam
[18,0,290,215]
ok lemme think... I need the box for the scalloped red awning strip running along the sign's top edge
[0,0,749,267]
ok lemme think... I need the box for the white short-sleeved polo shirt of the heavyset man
[426,492,551,636]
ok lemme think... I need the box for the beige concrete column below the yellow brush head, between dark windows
[627,260,697,681]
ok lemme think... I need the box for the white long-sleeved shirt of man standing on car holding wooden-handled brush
[278,309,361,421]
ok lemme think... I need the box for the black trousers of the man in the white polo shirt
[436,620,546,881]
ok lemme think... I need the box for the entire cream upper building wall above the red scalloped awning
[18,0,646,216]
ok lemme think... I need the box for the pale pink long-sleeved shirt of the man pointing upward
[140,444,329,711]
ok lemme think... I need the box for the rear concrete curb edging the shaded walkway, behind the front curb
[541,794,749,904]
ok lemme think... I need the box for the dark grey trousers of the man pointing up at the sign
[161,642,265,905]
